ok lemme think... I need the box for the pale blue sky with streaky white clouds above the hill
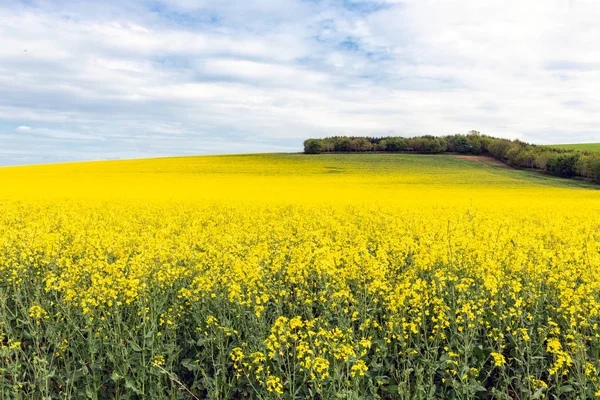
[0,0,600,165]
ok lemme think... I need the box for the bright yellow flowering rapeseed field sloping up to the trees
[0,154,600,399]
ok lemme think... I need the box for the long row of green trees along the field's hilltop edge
[304,131,600,183]
